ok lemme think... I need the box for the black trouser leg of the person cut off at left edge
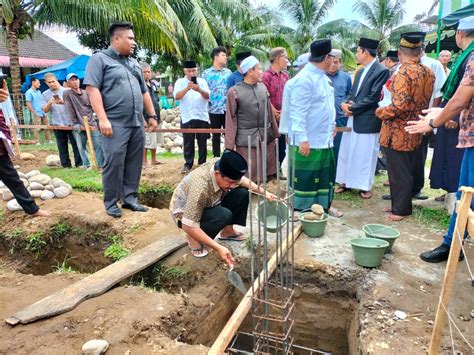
[0,154,39,214]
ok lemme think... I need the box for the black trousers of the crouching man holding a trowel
[178,187,249,238]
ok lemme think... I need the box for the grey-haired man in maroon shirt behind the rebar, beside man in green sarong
[262,47,290,172]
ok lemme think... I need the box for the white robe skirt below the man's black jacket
[336,116,380,191]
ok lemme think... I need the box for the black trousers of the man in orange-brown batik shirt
[384,148,418,216]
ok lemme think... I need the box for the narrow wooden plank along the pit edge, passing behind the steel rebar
[208,225,302,355]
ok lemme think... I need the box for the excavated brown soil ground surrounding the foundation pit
[0,152,474,354]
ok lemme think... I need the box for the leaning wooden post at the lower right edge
[428,186,474,355]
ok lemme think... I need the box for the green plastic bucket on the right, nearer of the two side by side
[350,238,388,267]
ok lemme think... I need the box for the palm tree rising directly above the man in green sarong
[278,0,336,53]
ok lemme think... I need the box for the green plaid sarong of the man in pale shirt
[288,145,336,211]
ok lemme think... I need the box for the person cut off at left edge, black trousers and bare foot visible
[0,80,51,217]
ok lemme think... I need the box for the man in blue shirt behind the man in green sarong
[328,49,352,162]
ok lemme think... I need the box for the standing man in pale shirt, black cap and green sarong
[288,39,342,217]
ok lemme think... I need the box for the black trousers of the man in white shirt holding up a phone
[181,120,209,169]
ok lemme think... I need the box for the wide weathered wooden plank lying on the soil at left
[5,238,187,325]
